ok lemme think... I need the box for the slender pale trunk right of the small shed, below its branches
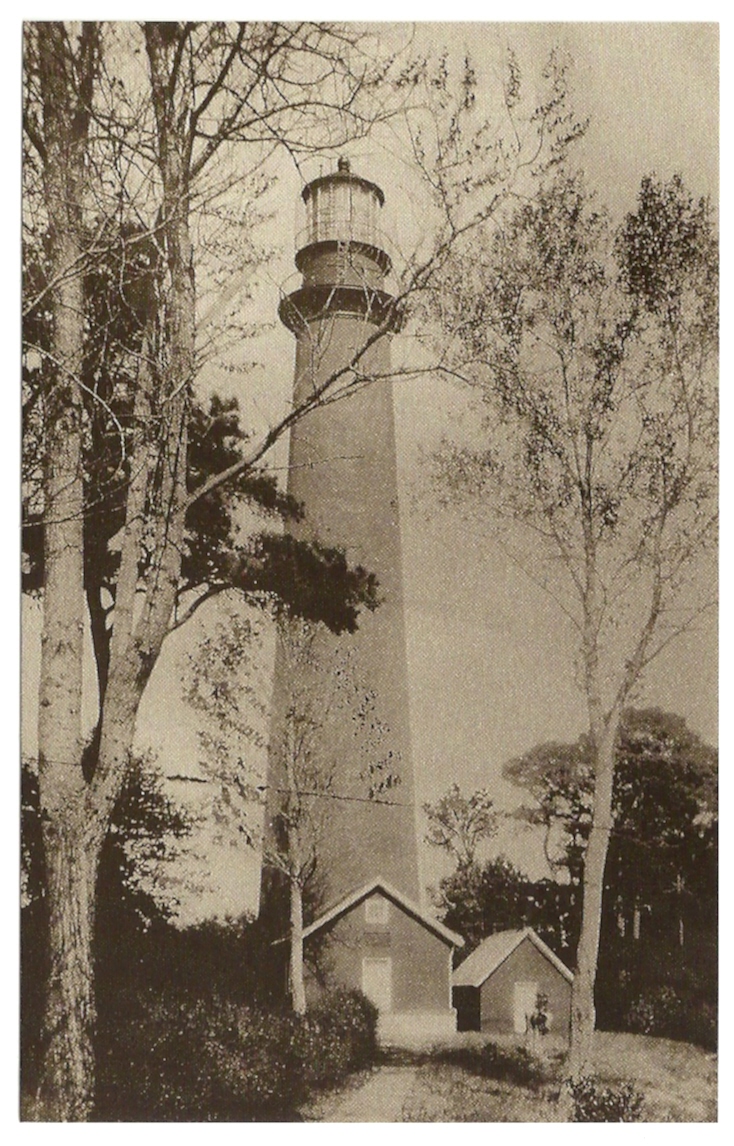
[568,727,616,1078]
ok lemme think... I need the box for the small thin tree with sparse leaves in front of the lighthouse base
[186,610,397,1014]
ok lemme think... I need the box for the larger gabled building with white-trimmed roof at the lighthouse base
[304,878,463,1041]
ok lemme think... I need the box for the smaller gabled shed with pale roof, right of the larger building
[452,927,573,1038]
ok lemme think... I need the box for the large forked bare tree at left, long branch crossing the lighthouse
[24,23,584,1118]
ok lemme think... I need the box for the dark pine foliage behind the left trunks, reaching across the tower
[23,286,378,669]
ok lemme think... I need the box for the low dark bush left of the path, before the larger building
[96,991,377,1122]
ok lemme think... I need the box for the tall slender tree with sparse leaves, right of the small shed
[437,170,717,1075]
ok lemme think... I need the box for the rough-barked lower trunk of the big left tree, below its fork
[40,802,101,1122]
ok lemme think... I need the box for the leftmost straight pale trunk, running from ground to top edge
[38,23,101,1120]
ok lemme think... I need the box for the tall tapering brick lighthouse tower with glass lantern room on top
[268,158,420,901]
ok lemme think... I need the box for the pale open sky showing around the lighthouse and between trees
[15,17,718,918]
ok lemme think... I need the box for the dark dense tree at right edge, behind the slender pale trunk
[505,709,718,1038]
